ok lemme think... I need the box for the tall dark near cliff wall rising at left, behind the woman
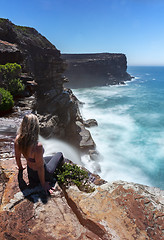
[0,19,92,147]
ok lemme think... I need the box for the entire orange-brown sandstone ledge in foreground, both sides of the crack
[0,119,164,240]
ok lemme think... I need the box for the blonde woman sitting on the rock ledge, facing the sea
[14,114,63,193]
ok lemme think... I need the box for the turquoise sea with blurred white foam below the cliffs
[73,67,164,189]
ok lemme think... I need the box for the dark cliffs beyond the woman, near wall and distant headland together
[0,19,130,149]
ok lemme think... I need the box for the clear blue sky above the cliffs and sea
[0,0,164,66]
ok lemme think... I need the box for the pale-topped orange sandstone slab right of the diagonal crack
[66,182,164,240]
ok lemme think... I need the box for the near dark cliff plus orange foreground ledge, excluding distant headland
[0,19,164,240]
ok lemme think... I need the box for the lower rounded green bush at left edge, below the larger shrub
[0,88,14,113]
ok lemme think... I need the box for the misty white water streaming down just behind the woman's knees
[39,136,82,165]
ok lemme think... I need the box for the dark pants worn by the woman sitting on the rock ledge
[27,152,63,186]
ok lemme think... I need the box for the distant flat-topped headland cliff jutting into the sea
[62,53,131,88]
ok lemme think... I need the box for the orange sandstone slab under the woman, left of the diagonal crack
[0,149,106,240]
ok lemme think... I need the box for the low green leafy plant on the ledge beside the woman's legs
[55,163,95,192]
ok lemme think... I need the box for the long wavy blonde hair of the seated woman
[17,114,39,155]
